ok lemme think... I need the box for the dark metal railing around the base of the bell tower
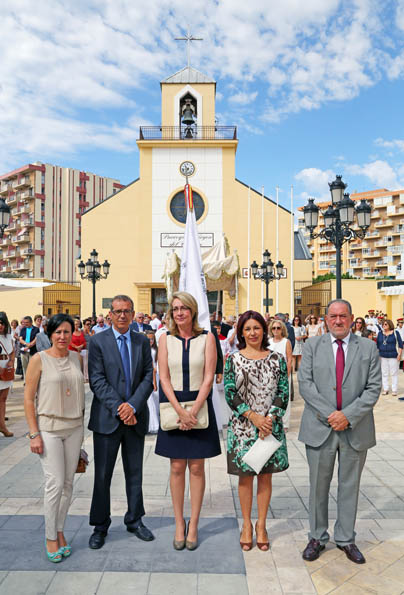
[139,126,237,140]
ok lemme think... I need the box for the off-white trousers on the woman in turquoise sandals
[40,426,84,540]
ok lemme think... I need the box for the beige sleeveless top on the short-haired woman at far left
[36,351,84,432]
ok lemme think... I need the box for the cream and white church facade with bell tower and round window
[81,66,311,316]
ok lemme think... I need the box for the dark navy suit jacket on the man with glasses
[88,329,153,436]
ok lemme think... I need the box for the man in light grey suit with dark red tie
[298,300,381,564]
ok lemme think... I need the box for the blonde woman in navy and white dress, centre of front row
[156,291,220,550]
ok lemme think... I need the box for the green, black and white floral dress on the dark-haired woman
[224,351,289,475]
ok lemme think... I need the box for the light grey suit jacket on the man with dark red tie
[298,333,381,450]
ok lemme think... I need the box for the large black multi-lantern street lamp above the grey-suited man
[303,176,372,299]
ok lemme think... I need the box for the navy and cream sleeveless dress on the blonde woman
[155,331,221,459]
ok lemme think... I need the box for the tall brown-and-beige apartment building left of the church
[0,162,124,281]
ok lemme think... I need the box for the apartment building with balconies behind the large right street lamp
[298,188,404,279]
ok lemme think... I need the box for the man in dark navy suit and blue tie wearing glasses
[88,295,154,549]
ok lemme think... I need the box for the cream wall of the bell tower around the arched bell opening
[161,83,216,126]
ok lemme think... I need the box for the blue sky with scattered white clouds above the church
[0,0,404,212]
